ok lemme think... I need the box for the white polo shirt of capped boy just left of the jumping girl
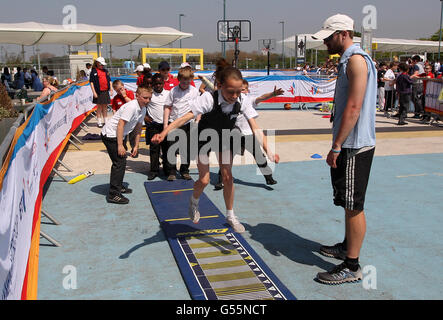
[165,85,199,123]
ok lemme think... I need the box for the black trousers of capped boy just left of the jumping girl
[166,123,191,174]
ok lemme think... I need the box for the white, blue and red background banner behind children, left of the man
[111,72,336,103]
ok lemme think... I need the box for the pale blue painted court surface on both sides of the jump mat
[38,154,443,300]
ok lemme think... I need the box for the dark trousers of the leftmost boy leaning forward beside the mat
[101,135,126,196]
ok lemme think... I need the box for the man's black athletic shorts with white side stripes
[331,147,375,211]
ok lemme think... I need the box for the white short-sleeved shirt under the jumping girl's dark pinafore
[189,90,258,135]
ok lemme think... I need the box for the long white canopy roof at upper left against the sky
[0,22,192,47]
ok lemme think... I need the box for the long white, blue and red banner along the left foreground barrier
[0,82,94,299]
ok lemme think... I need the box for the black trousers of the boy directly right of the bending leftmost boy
[145,122,171,175]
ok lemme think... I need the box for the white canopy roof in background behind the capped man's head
[279,34,438,53]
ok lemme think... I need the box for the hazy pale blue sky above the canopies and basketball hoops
[0,0,441,57]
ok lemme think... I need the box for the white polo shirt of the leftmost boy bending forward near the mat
[102,99,146,139]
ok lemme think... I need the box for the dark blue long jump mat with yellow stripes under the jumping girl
[145,180,295,300]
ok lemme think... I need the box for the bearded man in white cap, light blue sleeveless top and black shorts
[312,14,377,284]
